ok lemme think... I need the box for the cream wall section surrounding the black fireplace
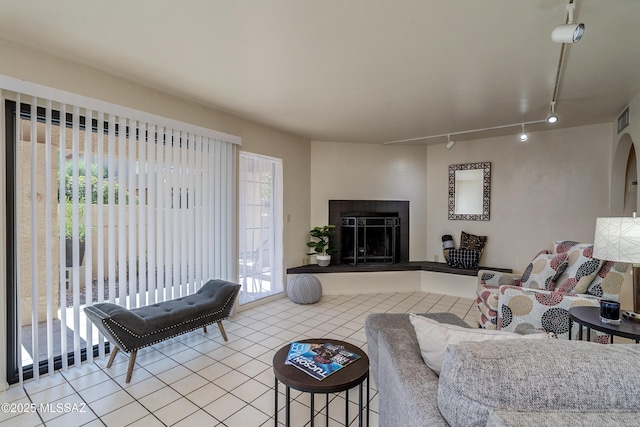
[312,141,427,261]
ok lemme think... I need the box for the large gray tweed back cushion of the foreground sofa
[438,340,640,426]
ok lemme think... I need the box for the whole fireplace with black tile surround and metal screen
[329,200,409,264]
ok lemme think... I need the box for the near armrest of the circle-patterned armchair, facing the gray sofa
[498,286,608,343]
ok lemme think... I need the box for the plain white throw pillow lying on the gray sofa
[409,313,552,375]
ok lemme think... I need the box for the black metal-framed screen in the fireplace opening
[340,216,400,264]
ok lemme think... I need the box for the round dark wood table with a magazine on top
[273,338,369,426]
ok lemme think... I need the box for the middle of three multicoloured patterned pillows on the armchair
[553,241,603,293]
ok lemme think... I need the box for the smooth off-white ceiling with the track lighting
[0,0,640,144]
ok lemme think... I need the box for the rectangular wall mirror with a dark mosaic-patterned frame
[449,162,491,221]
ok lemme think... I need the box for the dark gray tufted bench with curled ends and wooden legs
[84,279,240,383]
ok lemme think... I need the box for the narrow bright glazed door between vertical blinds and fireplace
[238,152,284,304]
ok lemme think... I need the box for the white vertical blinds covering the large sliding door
[0,80,239,381]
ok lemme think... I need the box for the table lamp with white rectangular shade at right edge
[593,216,640,322]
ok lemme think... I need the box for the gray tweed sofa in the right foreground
[365,313,640,427]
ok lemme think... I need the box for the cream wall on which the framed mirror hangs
[426,124,612,272]
